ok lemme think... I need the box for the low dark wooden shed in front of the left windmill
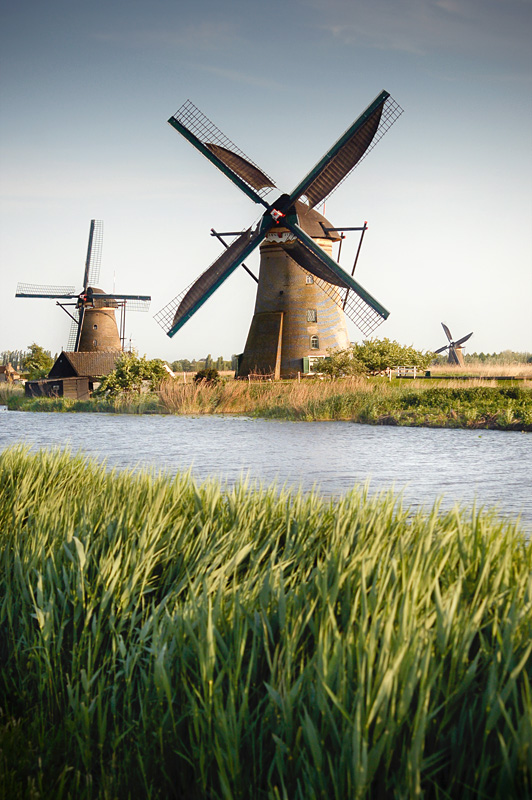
[26,350,122,400]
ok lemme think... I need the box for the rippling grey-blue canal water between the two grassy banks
[0,411,532,531]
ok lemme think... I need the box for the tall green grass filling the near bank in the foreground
[0,448,532,800]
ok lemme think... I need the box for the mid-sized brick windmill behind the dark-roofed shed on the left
[15,219,151,353]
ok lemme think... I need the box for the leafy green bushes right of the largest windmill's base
[314,339,434,378]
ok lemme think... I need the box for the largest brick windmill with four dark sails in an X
[155,91,402,377]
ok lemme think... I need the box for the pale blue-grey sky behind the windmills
[0,0,532,361]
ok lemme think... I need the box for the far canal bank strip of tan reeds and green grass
[0,378,532,431]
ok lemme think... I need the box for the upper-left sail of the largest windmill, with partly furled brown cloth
[168,100,275,205]
